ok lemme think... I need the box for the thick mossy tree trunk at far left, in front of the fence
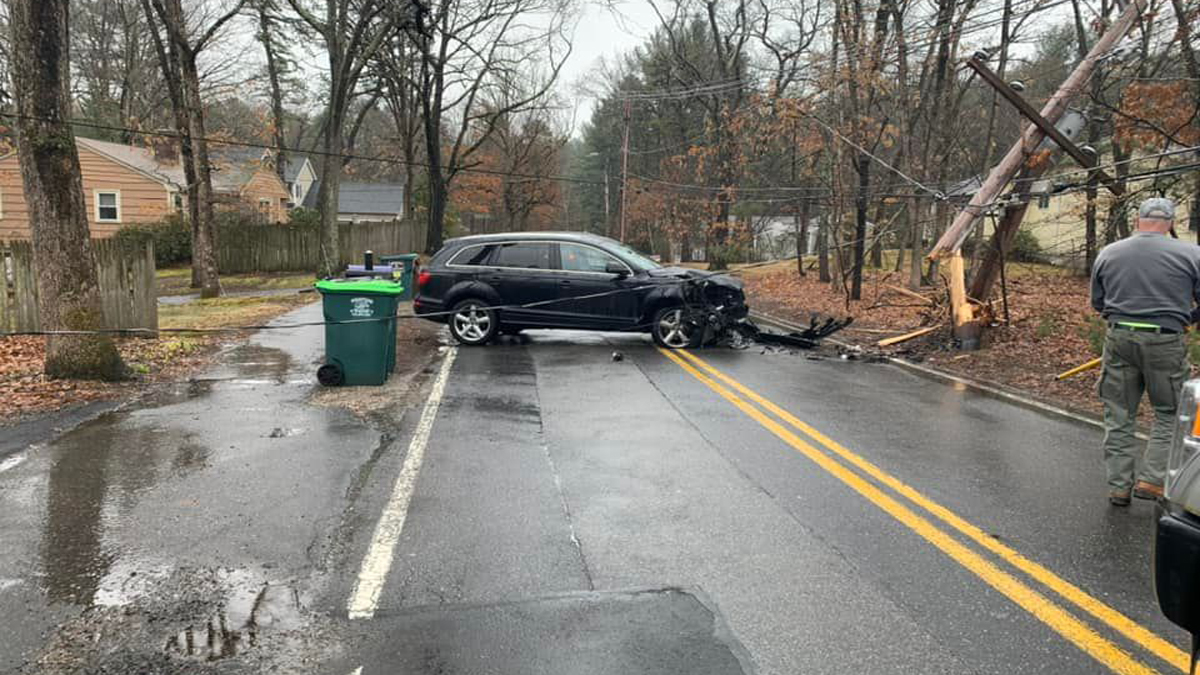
[8,0,125,380]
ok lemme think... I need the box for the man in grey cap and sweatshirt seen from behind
[1092,197,1200,506]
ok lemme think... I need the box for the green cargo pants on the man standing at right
[1099,328,1190,490]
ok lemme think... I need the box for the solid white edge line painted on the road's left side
[346,347,458,619]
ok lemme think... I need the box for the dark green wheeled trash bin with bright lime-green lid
[316,279,404,387]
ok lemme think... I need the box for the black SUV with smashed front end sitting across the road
[413,232,748,350]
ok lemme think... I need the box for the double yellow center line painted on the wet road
[659,348,1189,675]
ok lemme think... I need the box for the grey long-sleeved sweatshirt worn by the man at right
[1092,232,1200,330]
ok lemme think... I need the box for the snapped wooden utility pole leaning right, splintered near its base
[929,0,1144,348]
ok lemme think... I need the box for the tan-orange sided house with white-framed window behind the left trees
[0,137,289,240]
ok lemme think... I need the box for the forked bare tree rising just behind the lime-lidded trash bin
[288,0,405,276]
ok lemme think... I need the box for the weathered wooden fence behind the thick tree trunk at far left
[0,239,158,330]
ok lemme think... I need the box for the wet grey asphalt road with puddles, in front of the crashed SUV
[0,309,1184,674]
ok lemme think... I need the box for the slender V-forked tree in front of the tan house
[142,0,247,298]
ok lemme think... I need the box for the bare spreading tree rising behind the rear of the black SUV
[408,0,571,252]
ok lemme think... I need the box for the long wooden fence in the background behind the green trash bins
[217,220,425,274]
